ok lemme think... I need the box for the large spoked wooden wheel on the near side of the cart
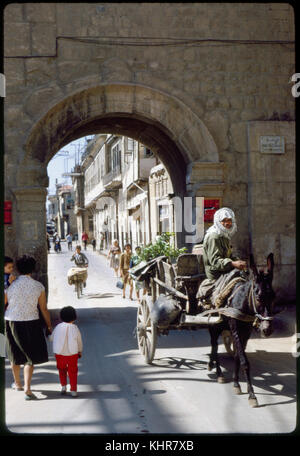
[137,299,157,364]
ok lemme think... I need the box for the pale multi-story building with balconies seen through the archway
[73,134,157,249]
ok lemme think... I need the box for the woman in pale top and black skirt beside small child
[4,255,52,400]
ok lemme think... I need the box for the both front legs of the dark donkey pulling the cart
[229,319,258,407]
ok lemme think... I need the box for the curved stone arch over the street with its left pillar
[10,84,218,284]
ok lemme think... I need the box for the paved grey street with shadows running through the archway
[6,243,296,434]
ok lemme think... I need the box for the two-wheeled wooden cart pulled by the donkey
[131,253,233,364]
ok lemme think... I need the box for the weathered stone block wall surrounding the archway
[4,3,295,302]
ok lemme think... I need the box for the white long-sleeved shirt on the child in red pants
[51,322,82,356]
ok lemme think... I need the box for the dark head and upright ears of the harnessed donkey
[250,253,275,336]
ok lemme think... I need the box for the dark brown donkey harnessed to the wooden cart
[208,253,275,407]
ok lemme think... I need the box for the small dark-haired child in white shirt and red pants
[52,306,82,397]
